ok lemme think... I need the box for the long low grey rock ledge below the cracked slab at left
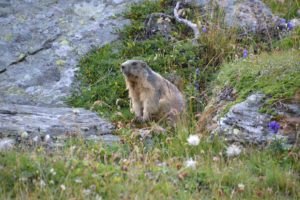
[0,104,114,138]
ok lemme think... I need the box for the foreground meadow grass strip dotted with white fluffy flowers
[0,127,300,199]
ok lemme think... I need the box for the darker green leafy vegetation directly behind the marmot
[68,0,300,121]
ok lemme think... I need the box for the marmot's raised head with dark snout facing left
[121,60,150,80]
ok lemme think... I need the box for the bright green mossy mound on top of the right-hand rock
[212,50,300,112]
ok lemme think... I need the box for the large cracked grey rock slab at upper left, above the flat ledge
[0,0,136,106]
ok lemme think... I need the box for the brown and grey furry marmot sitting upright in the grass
[121,60,185,122]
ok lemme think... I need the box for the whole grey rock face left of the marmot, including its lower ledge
[0,0,138,147]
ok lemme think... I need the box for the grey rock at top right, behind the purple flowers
[190,0,297,39]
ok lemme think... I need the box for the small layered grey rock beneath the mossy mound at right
[215,93,300,144]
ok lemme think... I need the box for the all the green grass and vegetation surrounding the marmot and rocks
[0,0,300,199]
